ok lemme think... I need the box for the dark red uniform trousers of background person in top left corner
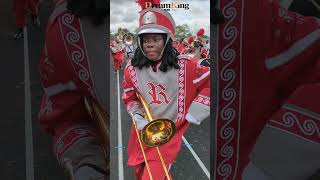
[13,0,39,28]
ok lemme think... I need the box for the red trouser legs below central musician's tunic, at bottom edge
[134,160,172,180]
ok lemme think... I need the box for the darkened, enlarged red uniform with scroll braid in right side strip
[212,0,320,180]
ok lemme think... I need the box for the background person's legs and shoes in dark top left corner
[13,0,40,39]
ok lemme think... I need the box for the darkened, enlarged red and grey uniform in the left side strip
[39,0,107,172]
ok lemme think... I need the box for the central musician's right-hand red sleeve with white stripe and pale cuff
[186,62,210,124]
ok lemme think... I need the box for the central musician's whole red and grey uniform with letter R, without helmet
[122,58,210,179]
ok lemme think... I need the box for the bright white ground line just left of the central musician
[117,71,124,180]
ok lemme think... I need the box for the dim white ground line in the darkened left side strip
[23,26,34,180]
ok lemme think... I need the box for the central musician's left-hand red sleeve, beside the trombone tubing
[122,66,143,115]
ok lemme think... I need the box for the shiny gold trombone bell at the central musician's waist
[140,119,176,147]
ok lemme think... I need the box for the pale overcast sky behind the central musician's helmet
[110,0,210,35]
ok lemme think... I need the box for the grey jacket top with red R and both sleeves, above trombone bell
[122,56,210,124]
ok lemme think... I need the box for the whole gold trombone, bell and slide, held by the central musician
[133,92,176,180]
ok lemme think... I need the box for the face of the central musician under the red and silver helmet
[142,34,164,61]
